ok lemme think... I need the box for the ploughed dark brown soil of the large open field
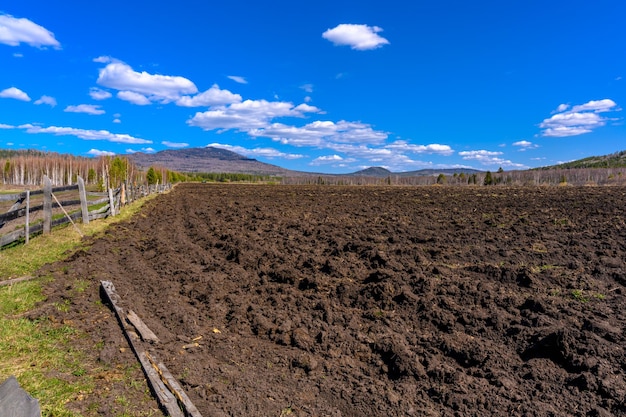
[39,184,626,417]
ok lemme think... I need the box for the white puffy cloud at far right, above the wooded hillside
[539,99,620,137]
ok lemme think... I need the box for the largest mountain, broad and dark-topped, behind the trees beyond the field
[128,146,293,176]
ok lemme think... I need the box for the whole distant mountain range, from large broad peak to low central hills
[127,146,481,178]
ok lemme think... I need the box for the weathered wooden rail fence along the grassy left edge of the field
[0,177,171,248]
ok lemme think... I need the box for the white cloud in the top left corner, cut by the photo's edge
[0,14,61,49]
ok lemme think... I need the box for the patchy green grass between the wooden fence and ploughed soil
[0,194,161,417]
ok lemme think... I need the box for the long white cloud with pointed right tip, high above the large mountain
[187,100,320,131]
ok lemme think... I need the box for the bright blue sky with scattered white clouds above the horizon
[0,0,626,173]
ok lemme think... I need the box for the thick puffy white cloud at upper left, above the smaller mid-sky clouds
[96,61,198,103]
